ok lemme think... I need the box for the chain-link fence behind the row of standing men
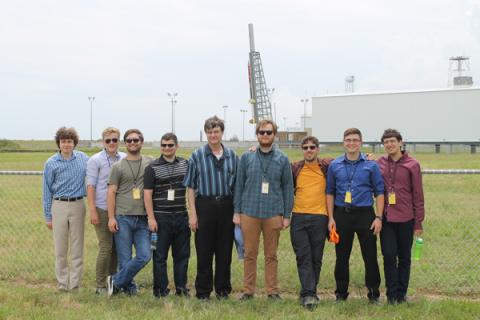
[0,172,480,296]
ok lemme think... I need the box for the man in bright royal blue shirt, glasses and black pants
[327,128,384,303]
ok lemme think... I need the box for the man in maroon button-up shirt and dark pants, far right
[378,129,425,304]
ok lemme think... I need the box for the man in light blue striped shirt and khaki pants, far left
[43,127,88,291]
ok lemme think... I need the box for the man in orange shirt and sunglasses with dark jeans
[290,136,333,309]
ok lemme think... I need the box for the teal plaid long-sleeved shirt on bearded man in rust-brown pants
[234,148,293,218]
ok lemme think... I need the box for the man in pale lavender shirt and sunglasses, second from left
[87,127,126,294]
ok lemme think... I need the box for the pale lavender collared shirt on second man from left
[87,150,126,210]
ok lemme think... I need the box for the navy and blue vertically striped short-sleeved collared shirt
[183,144,238,197]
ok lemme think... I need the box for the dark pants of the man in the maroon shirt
[380,220,414,302]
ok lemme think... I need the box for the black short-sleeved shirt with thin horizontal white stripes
[143,156,188,214]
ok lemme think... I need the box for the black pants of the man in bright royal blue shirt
[334,207,380,299]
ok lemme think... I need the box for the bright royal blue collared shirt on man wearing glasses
[327,153,384,207]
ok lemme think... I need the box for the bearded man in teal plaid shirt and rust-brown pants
[233,120,293,300]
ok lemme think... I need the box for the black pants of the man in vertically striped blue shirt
[195,197,234,298]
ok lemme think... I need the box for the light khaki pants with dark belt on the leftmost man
[52,200,85,290]
